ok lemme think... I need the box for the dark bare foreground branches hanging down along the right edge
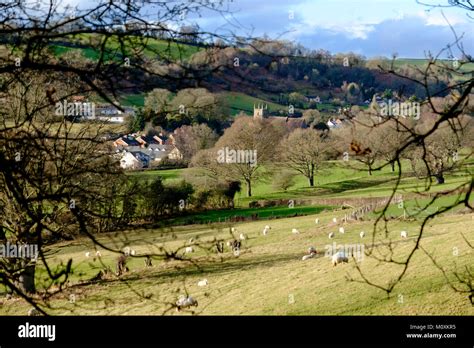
[348,1,474,303]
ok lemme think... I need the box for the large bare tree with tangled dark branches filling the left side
[0,0,244,314]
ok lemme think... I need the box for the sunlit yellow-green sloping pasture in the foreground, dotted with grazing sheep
[0,211,474,315]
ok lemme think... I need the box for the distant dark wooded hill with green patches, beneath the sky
[41,34,452,115]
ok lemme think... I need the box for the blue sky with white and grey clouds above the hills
[66,0,474,58]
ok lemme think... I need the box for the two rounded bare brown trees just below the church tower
[191,116,333,196]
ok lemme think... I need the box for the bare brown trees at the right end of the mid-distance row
[334,98,474,183]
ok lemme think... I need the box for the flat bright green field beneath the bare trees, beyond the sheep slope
[129,161,473,207]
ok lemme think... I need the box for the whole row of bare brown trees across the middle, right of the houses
[191,94,474,196]
